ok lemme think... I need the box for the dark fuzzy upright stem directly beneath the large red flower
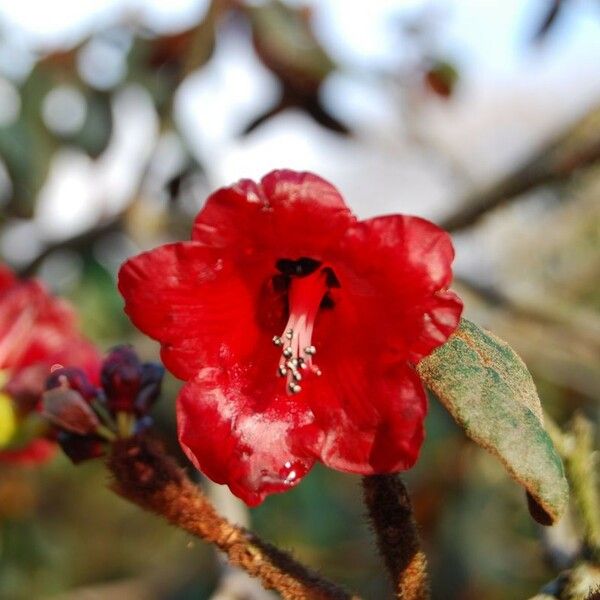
[362,475,429,600]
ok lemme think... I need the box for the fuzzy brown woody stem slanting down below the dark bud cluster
[107,436,355,600]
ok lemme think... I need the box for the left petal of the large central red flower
[119,242,259,379]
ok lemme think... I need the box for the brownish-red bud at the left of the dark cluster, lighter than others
[42,387,100,435]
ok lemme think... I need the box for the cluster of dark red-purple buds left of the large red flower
[42,346,164,463]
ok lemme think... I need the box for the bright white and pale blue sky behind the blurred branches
[0,0,600,282]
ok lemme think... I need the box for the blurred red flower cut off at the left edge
[0,265,100,464]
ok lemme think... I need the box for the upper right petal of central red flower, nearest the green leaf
[335,215,462,363]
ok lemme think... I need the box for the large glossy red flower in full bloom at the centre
[119,171,462,505]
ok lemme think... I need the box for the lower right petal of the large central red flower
[301,353,427,475]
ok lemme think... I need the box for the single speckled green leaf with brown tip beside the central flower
[417,319,569,525]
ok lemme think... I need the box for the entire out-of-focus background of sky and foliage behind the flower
[0,0,600,600]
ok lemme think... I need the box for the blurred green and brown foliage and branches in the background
[0,0,600,600]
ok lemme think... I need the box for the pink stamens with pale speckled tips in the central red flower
[273,259,335,394]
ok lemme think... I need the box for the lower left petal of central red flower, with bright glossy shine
[177,368,314,506]
